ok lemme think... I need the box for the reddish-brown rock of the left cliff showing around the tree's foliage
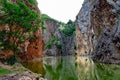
[0,0,44,61]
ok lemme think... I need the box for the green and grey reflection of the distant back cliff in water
[44,57,78,80]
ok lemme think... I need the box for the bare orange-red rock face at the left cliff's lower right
[17,31,44,61]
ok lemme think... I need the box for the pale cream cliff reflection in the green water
[76,57,95,80]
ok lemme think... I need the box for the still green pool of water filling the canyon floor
[23,56,120,80]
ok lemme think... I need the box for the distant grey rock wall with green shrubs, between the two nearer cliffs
[43,19,75,56]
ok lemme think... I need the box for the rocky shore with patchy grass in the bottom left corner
[0,63,47,80]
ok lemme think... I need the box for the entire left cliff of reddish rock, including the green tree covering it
[0,0,44,61]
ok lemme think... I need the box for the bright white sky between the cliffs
[37,0,84,22]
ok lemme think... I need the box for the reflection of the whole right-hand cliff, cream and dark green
[77,57,120,80]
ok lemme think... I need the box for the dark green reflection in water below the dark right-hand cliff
[94,63,120,80]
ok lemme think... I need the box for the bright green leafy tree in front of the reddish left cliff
[0,0,40,50]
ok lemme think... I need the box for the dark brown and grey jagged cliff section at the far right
[91,0,120,62]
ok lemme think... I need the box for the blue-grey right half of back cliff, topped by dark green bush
[58,22,75,56]
